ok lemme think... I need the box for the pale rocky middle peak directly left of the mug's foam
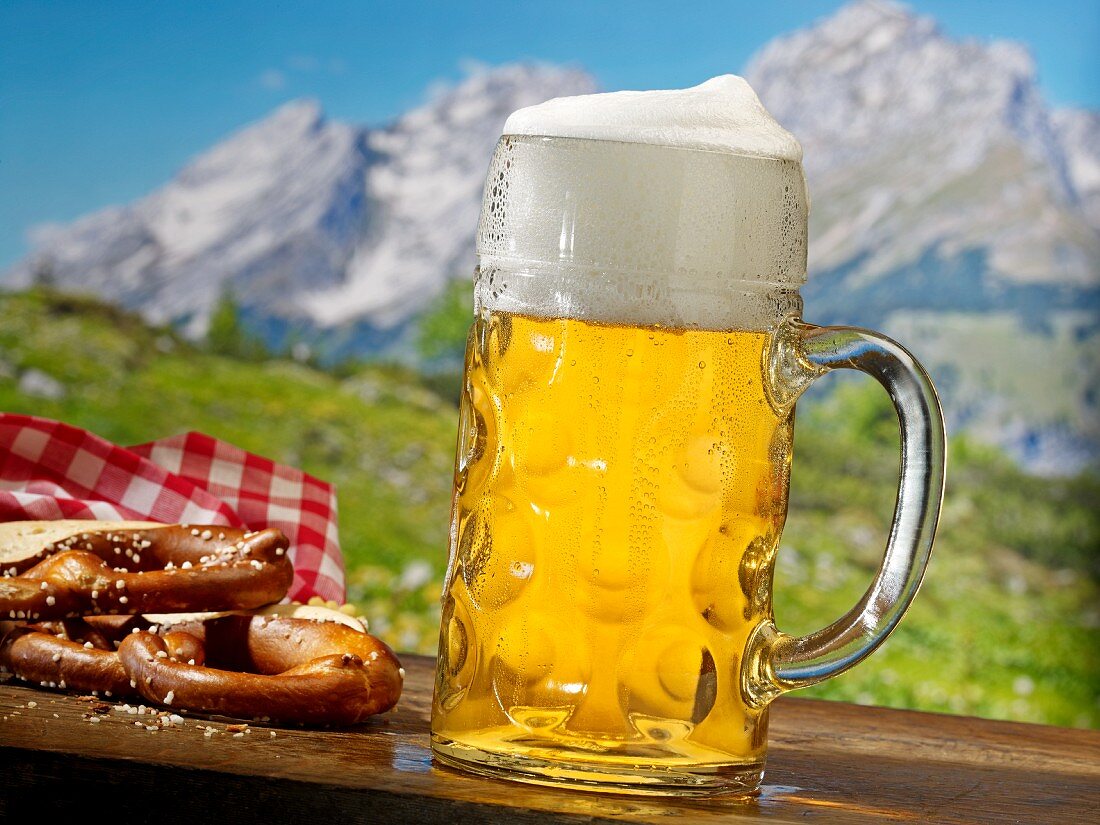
[306,65,594,328]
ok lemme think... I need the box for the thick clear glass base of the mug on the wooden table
[431,734,763,796]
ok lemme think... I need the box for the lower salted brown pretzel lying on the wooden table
[0,608,405,725]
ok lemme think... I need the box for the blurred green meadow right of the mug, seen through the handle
[776,380,1100,727]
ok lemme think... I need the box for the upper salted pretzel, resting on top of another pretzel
[0,521,294,622]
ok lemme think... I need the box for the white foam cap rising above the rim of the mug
[504,75,802,163]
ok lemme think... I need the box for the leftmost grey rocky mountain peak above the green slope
[10,101,371,332]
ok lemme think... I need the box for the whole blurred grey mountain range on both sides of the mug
[8,0,1100,473]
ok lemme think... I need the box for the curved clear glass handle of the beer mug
[741,320,944,706]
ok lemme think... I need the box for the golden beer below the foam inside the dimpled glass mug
[432,310,792,790]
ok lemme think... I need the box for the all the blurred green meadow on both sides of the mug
[0,292,1100,727]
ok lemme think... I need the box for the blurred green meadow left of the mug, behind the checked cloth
[0,293,457,638]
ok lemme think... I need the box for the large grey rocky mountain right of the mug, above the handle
[746,0,1100,473]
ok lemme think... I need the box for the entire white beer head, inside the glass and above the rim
[475,75,810,330]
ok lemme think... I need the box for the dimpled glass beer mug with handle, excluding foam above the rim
[431,122,944,794]
